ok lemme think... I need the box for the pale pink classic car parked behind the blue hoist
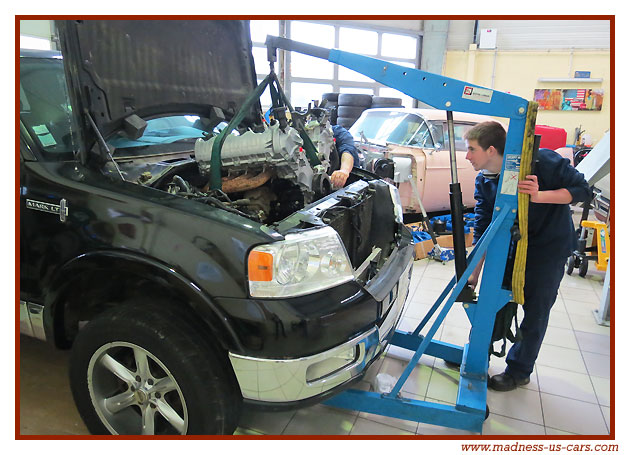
[350,108,502,214]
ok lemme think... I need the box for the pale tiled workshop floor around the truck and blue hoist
[20,251,610,435]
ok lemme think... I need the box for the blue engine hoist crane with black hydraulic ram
[266,36,538,433]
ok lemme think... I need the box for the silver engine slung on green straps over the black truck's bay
[131,113,337,223]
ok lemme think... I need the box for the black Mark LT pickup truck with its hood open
[19,20,413,434]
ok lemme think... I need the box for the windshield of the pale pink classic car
[350,111,434,147]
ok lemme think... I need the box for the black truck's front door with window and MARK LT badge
[20,51,83,303]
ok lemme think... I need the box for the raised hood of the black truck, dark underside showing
[57,20,260,143]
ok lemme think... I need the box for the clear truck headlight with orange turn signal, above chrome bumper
[247,226,354,297]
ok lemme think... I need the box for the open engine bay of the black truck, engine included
[111,108,339,224]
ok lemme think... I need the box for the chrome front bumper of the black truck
[229,261,413,403]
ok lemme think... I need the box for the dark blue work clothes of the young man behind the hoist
[473,149,591,380]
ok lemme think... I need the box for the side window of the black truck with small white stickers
[20,57,79,160]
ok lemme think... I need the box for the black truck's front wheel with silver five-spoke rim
[70,304,242,435]
